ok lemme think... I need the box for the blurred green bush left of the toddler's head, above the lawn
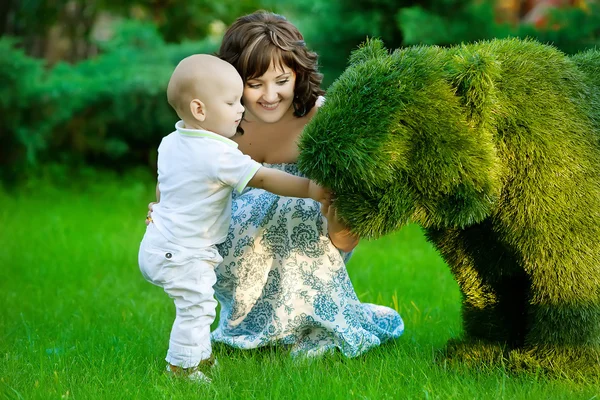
[0,23,218,180]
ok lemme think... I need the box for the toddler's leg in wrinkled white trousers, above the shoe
[163,258,217,368]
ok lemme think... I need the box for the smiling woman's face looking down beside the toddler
[243,62,296,123]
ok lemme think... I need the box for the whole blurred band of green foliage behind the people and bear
[0,0,600,185]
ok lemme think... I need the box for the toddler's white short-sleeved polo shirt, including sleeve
[152,121,261,248]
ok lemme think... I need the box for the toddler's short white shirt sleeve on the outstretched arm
[217,147,262,192]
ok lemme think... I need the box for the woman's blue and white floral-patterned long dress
[212,164,404,357]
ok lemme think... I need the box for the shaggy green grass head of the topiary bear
[298,40,501,238]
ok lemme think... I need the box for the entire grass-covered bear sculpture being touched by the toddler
[299,39,600,375]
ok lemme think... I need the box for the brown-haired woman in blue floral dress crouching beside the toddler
[213,11,404,357]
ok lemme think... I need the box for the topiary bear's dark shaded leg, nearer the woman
[427,221,530,364]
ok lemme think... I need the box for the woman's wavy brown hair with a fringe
[218,10,325,117]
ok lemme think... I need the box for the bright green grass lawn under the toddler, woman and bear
[0,175,600,399]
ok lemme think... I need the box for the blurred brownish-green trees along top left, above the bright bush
[0,0,264,64]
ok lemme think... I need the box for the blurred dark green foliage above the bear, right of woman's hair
[277,0,507,86]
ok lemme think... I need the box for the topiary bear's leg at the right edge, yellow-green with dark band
[509,260,600,378]
